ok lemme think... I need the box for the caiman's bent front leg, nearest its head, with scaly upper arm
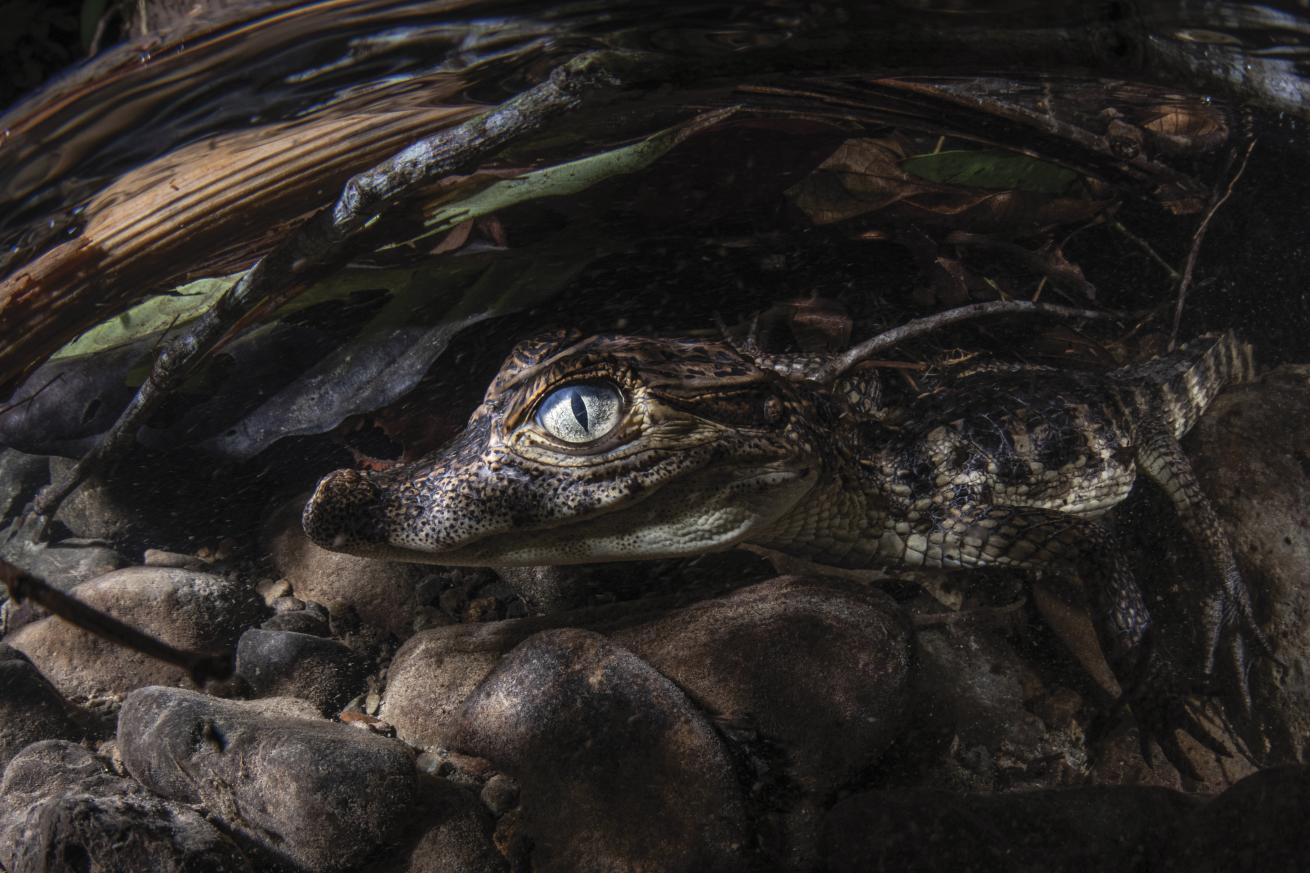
[906,506,1226,773]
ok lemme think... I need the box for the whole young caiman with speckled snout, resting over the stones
[304,326,1267,758]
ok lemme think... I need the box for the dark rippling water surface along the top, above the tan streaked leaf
[0,0,1306,245]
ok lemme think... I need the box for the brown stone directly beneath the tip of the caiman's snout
[266,495,424,638]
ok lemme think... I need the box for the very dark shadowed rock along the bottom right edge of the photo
[824,767,1310,873]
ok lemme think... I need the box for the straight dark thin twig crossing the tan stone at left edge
[0,561,232,684]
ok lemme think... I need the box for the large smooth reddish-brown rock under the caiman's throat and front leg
[612,577,912,869]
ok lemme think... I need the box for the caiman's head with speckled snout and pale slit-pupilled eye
[304,327,823,566]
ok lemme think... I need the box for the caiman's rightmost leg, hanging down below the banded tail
[1136,423,1272,714]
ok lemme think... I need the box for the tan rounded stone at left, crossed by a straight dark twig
[7,566,263,700]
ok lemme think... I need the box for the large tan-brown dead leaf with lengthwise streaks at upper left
[0,100,476,387]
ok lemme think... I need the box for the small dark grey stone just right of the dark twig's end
[237,628,369,714]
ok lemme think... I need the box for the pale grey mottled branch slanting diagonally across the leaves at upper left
[35,51,663,536]
